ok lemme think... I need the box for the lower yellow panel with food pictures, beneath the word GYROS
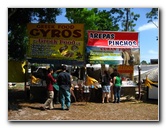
[27,38,84,61]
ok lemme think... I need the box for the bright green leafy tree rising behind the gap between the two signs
[65,8,119,42]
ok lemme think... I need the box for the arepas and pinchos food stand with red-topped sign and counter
[86,30,140,100]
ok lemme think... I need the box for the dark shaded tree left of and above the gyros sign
[8,8,61,60]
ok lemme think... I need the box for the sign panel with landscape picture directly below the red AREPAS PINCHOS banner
[86,46,140,65]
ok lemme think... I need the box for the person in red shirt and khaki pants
[42,68,56,110]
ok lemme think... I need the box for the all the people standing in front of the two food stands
[41,65,122,110]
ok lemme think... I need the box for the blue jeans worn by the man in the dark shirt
[59,88,71,109]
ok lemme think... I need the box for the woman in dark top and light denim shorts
[102,70,111,103]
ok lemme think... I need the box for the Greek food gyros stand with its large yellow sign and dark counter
[27,23,85,100]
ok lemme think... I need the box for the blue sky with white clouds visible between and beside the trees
[57,8,159,62]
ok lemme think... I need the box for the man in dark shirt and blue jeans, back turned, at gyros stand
[57,66,71,110]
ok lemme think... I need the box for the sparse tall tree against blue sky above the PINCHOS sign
[110,8,140,31]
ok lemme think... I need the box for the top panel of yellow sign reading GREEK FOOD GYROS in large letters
[27,23,84,41]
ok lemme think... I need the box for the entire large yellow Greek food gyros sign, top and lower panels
[27,24,85,61]
